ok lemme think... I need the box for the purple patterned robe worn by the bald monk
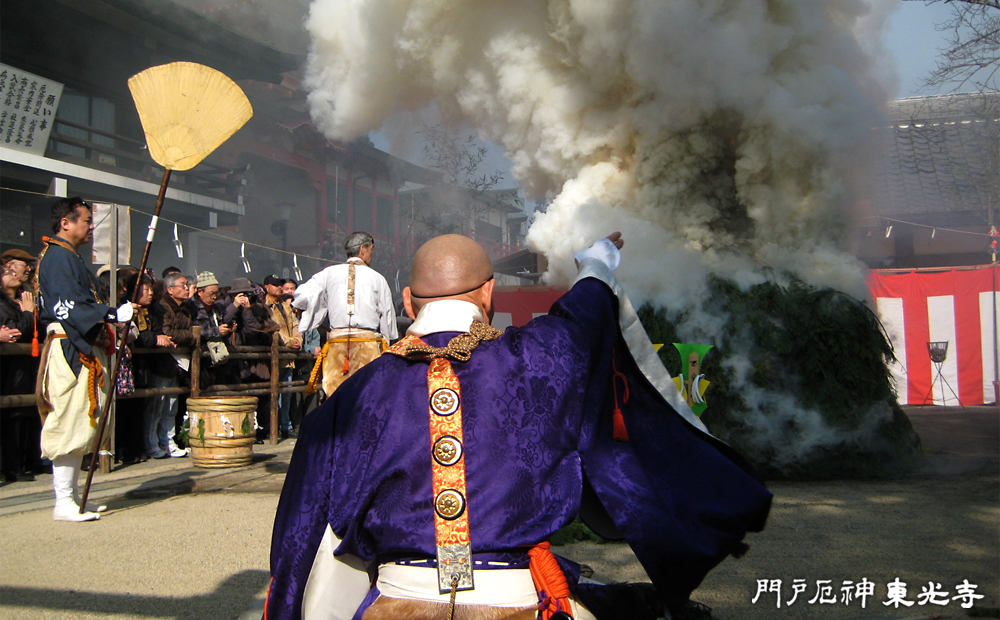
[266,278,771,620]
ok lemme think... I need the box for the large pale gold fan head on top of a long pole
[128,62,253,170]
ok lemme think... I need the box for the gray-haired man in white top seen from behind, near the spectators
[292,231,398,396]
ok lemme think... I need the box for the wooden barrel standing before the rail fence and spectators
[187,396,257,468]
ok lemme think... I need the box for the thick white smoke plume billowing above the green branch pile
[306,0,900,464]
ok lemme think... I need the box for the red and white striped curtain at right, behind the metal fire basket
[868,265,1000,406]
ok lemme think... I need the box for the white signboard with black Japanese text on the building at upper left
[0,64,63,155]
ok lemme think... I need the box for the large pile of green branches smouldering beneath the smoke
[639,278,920,479]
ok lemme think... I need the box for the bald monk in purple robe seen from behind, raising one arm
[265,233,770,620]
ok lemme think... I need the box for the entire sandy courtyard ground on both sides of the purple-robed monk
[0,408,1000,620]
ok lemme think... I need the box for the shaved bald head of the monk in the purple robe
[410,235,493,299]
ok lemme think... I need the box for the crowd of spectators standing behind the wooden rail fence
[0,249,326,482]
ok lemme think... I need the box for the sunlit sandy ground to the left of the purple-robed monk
[0,441,294,620]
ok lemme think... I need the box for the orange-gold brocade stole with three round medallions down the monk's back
[387,321,502,594]
